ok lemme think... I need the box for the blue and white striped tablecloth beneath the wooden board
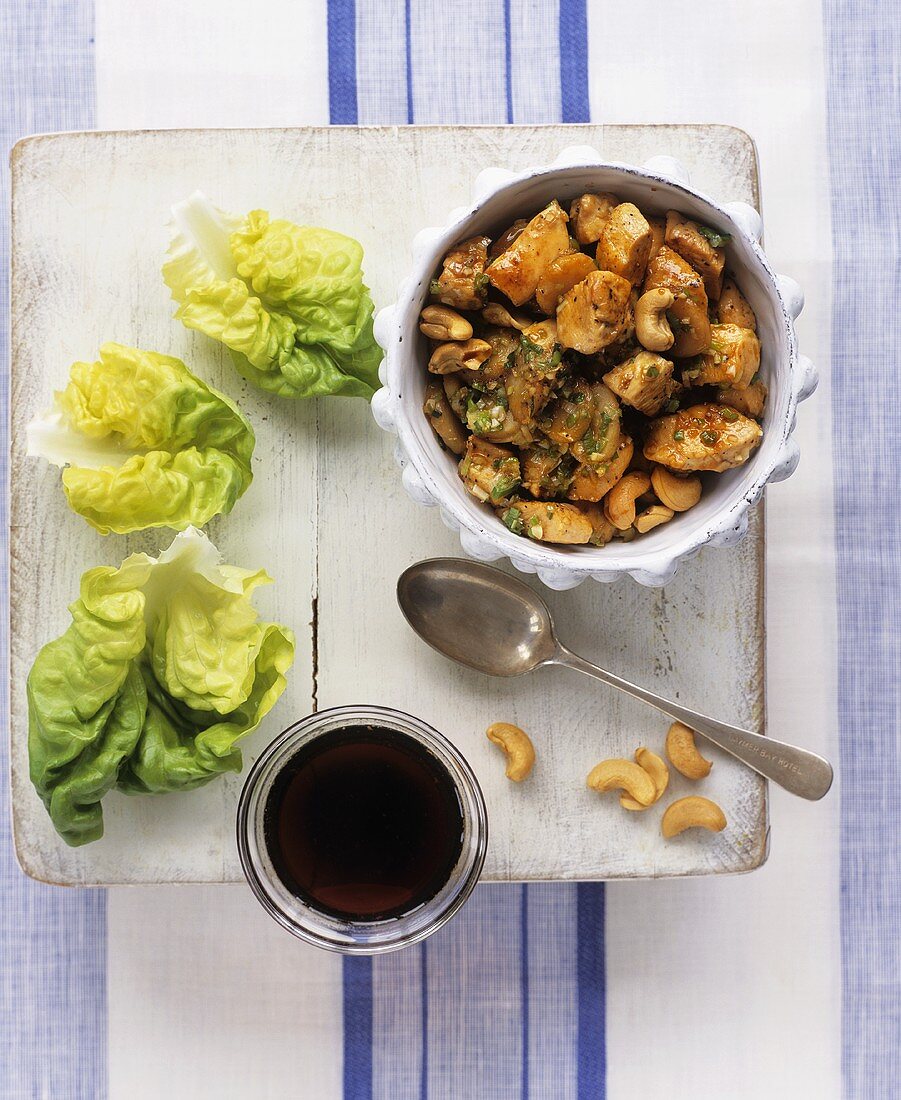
[0,0,901,1100]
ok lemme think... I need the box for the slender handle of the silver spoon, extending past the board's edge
[548,645,833,801]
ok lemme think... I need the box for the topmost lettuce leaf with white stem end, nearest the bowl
[163,191,382,398]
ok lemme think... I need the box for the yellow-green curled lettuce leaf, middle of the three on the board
[28,343,254,535]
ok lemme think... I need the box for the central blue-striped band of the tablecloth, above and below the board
[329,0,605,1100]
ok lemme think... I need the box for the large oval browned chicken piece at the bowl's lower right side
[645,405,763,473]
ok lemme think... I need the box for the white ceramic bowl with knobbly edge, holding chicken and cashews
[372,146,816,589]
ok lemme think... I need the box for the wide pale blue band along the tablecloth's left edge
[0,8,107,1100]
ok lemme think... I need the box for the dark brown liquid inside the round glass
[264,726,463,921]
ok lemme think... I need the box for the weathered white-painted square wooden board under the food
[10,127,767,884]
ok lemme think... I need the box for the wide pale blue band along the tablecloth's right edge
[823,0,901,1100]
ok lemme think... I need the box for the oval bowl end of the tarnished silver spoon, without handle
[397,558,558,677]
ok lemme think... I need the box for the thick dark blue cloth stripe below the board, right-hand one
[576,882,606,1100]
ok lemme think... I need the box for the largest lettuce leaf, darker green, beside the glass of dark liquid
[28,528,294,845]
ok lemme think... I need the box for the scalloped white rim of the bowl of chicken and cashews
[373,146,816,589]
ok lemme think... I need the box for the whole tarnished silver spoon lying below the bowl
[397,558,832,800]
